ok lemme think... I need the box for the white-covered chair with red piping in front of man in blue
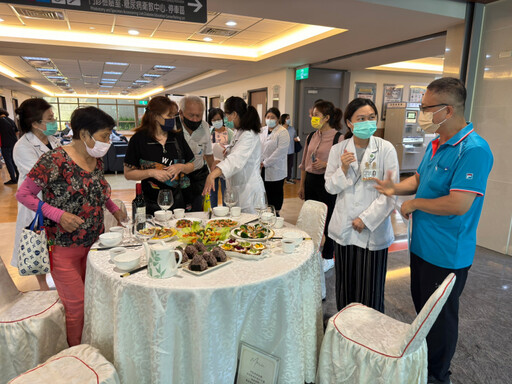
[316,273,455,384]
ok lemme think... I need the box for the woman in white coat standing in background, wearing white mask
[260,107,290,213]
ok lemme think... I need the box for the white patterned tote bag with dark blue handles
[18,201,50,276]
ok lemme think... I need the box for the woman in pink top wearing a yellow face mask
[299,100,343,272]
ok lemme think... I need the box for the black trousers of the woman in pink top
[304,172,336,259]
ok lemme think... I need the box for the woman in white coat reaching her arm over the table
[203,96,265,213]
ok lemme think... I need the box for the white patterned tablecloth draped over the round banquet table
[82,213,323,384]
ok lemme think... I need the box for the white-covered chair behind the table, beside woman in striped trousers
[296,200,327,298]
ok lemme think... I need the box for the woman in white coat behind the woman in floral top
[11,99,60,290]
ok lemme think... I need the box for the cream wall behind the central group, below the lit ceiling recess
[188,69,295,116]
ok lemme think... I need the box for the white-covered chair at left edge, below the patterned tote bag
[0,259,68,384]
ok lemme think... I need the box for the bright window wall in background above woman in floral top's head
[44,97,147,131]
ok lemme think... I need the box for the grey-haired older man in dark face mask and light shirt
[176,96,214,211]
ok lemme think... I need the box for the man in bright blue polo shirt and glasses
[376,77,493,383]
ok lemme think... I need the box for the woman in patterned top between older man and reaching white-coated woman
[208,108,234,208]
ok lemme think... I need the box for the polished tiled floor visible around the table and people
[0,169,512,384]
